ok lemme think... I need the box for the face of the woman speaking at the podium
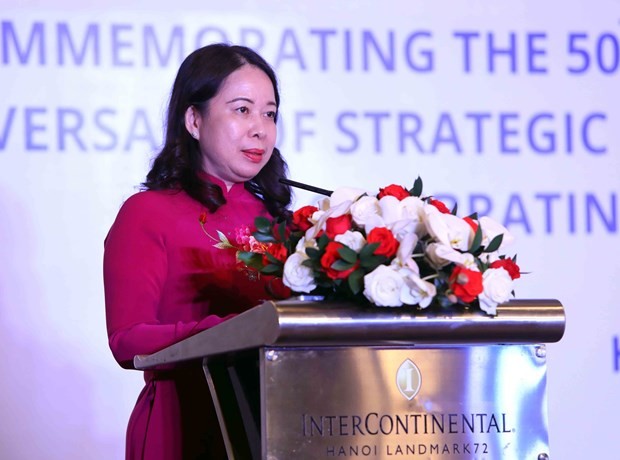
[185,64,277,189]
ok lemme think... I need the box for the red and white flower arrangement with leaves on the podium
[211,178,520,315]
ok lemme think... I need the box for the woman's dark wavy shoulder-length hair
[142,43,291,217]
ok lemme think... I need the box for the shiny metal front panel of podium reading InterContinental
[259,345,549,460]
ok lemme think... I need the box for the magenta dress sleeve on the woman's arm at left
[103,193,232,368]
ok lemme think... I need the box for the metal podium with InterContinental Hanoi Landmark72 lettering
[134,297,565,460]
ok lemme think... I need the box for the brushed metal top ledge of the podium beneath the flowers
[134,298,566,369]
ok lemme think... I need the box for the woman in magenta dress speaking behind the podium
[104,44,291,459]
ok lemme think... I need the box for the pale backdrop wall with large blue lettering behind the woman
[0,0,620,460]
